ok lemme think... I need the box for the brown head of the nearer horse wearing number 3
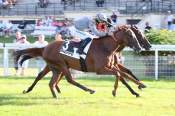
[114,26,141,52]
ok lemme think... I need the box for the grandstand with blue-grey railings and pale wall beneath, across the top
[0,0,175,28]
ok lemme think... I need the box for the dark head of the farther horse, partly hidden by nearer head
[131,26,151,50]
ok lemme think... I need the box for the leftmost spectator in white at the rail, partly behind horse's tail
[16,35,30,76]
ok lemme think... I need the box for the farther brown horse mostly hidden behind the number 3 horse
[21,26,151,96]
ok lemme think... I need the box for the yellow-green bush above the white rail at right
[146,29,175,44]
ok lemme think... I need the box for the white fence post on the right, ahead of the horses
[155,49,159,80]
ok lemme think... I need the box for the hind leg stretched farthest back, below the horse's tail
[23,65,50,94]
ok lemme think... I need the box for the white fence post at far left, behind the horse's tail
[3,45,9,76]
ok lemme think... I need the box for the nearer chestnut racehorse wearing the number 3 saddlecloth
[14,25,144,97]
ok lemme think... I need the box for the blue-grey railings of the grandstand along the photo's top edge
[0,0,175,16]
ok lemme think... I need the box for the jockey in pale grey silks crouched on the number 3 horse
[69,13,112,57]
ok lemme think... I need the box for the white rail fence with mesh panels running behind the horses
[0,43,175,80]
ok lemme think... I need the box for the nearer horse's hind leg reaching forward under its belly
[62,68,95,94]
